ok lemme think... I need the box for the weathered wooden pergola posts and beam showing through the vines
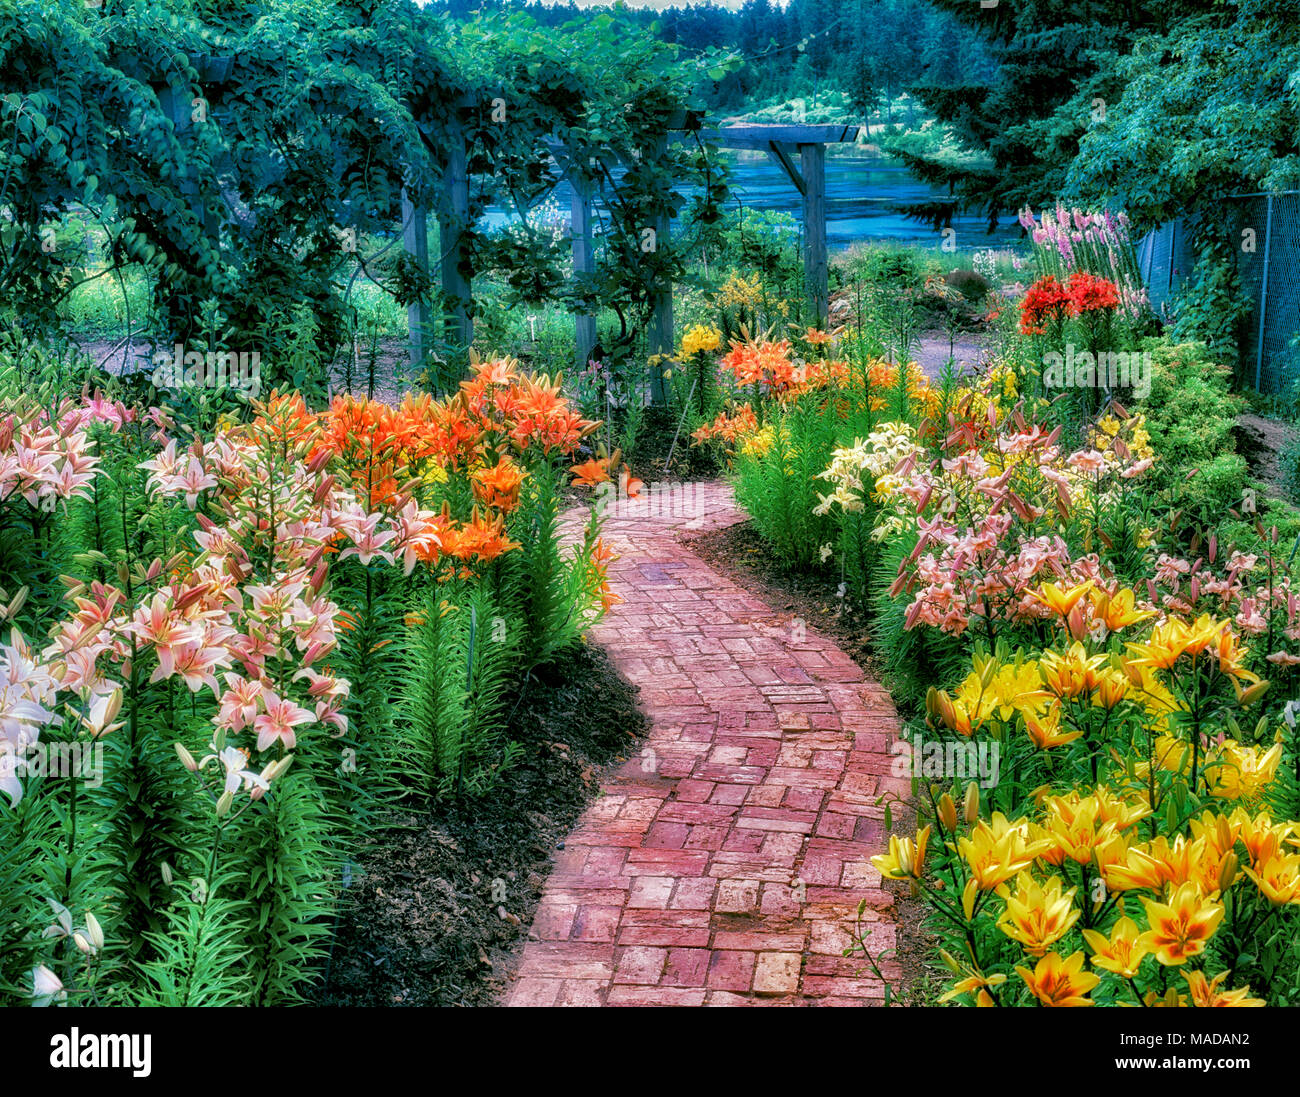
[402,118,858,403]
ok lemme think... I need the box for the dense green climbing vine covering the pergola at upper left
[0,0,732,393]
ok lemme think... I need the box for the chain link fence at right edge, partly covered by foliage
[1138,191,1300,394]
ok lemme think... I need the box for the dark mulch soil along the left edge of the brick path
[315,647,646,1006]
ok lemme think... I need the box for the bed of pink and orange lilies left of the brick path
[0,360,612,1005]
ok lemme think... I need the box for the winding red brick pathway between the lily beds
[506,484,907,1006]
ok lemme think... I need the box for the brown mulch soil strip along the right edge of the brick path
[690,521,939,1005]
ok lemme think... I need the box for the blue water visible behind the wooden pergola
[485,155,1021,251]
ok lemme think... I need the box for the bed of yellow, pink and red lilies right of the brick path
[697,272,1300,1006]
